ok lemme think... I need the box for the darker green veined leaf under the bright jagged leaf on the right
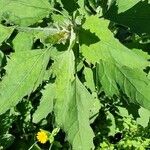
[97,60,150,110]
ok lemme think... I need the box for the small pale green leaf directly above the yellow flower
[33,84,55,123]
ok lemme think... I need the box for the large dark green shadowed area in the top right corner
[104,0,150,34]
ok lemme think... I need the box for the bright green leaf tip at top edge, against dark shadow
[116,0,141,13]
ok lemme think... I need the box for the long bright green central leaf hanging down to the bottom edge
[54,51,94,150]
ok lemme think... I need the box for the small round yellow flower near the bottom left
[36,130,48,144]
